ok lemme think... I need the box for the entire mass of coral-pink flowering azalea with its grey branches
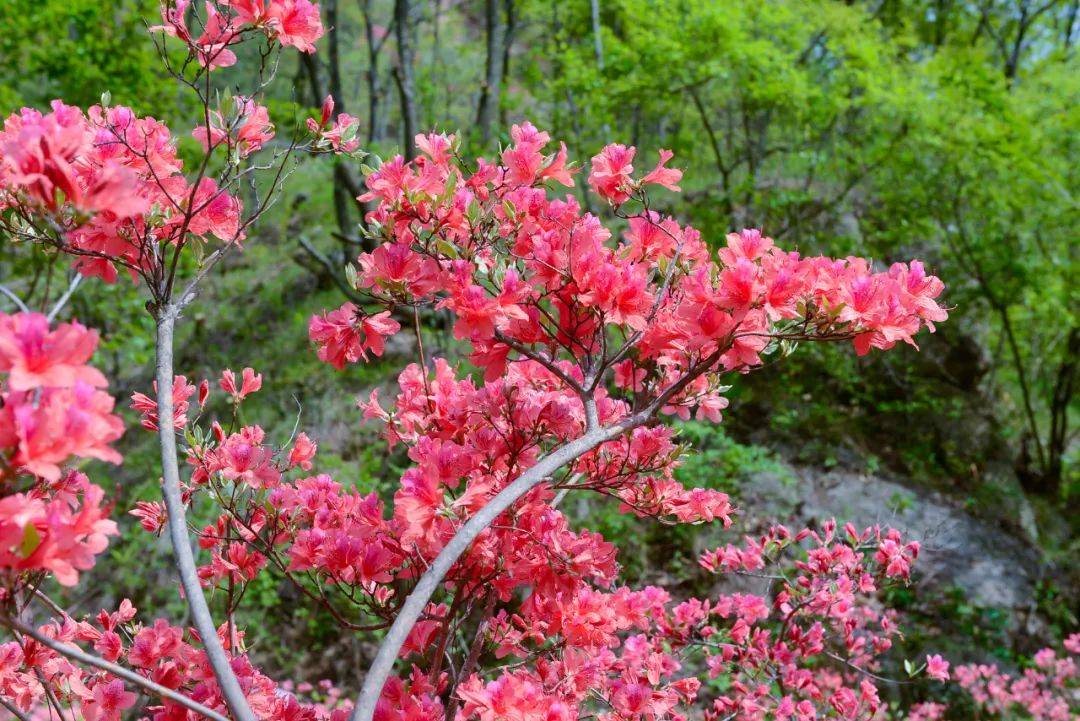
[0,0,1062,721]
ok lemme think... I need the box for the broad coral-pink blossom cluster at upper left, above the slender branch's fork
[0,100,243,283]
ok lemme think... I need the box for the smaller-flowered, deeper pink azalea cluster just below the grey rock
[701,521,915,720]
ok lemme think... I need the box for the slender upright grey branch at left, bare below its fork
[157,303,255,721]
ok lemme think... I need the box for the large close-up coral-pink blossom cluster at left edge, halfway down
[0,313,123,591]
